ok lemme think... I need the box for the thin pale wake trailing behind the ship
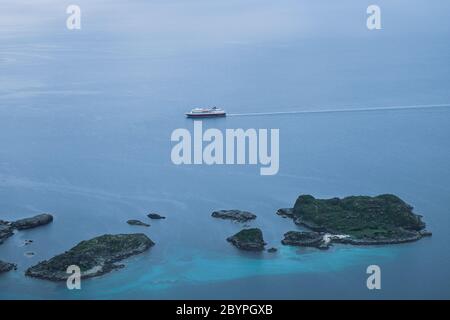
[228,104,450,117]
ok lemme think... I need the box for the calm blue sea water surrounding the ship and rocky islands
[0,0,450,299]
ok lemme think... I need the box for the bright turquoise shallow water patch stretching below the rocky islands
[87,248,392,297]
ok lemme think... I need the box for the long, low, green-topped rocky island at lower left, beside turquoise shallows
[25,233,154,281]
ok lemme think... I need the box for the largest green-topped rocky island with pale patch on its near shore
[277,194,431,248]
